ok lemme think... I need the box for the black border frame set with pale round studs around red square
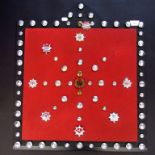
[13,3,147,152]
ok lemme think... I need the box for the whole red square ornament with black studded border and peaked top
[13,3,147,151]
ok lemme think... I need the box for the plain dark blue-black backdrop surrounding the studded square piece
[0,0,155,155]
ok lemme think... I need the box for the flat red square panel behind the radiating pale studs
[22,28,138,142]
